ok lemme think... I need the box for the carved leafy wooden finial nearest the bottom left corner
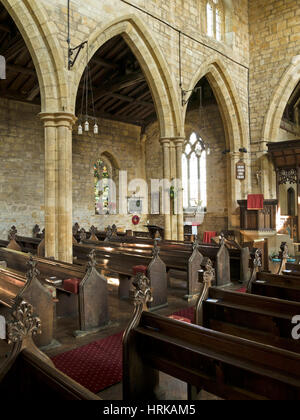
[7,298,42,344]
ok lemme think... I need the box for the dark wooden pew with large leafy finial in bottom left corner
[0,298,100,398]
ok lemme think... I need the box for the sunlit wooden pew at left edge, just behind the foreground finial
[0,257,54,347]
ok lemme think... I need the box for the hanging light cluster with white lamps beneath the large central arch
[78,41,99,136]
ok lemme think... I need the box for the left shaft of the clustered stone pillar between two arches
[160,138,172,240]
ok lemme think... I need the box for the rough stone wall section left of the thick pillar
[0,99,44,239]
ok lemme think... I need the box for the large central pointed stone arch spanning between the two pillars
[72,15,183,137]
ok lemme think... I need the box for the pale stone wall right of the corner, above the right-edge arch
[249,0,300,143]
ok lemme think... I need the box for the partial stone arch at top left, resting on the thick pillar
[0,0,68,112]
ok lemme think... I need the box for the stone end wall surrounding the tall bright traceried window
[146,101,228,236]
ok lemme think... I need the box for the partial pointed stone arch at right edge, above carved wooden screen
[262,55,300,142]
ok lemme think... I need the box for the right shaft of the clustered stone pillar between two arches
[174,138,184,241]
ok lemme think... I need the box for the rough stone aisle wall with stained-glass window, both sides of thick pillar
[0,100,147,239]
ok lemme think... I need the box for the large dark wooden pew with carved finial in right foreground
[123,277,300,401]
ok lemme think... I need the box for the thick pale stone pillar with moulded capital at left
[40,112,75,263]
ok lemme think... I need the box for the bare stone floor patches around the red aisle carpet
[0,282,241,400]
